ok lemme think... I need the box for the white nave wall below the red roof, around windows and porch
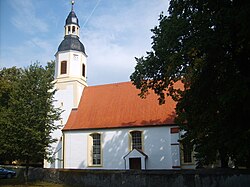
[64,127,179,169]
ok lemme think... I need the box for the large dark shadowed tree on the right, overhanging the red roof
[131,0,250,167]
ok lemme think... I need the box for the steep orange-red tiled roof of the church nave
[63,82,181,130]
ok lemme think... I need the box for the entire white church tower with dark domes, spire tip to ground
[44,1,87,168]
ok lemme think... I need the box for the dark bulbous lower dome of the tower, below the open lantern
[58,35,85,54]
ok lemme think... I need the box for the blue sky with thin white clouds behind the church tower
[0,0,169,85]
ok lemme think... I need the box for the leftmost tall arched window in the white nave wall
[90,133,101,166]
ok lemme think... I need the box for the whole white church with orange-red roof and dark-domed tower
[44,1,195,170]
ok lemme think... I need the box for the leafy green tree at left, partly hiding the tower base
[0,62,61,175]
